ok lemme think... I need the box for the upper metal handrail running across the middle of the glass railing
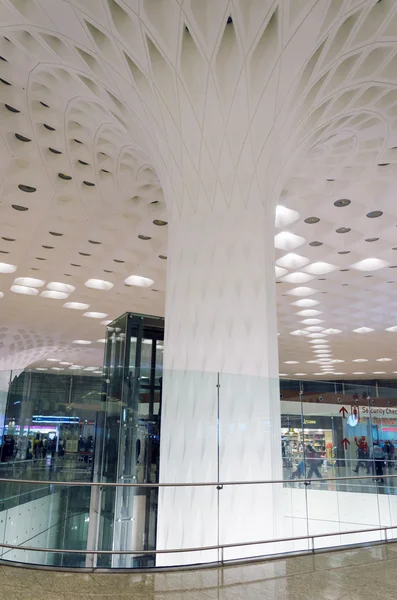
[0,474,397,488]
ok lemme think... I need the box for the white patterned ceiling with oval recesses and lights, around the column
[0,0,397,378]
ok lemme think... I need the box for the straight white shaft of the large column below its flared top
[157,202,281,565]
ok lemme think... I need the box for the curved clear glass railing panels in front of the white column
[0,367,397,569]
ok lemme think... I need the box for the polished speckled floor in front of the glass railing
[0,544,397,600]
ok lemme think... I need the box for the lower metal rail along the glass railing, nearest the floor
[0,525,390,555]
